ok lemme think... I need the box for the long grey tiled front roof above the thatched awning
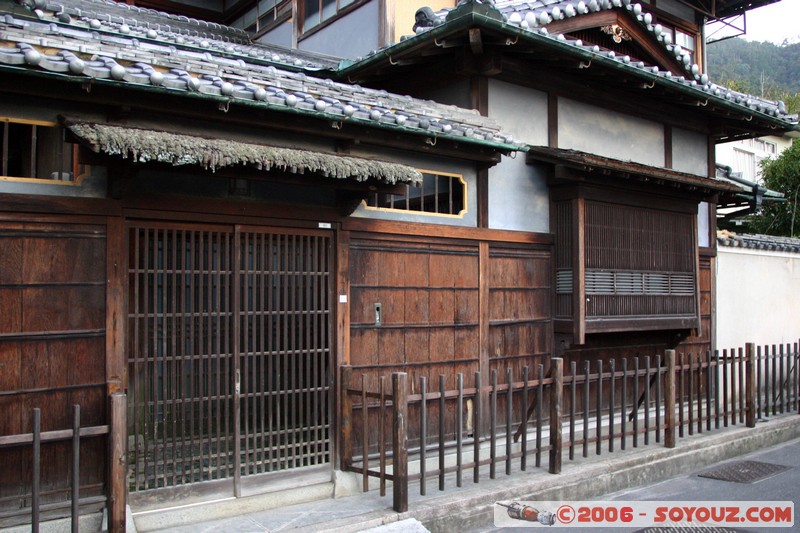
[0,4,525,151]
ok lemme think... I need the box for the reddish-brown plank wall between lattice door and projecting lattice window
[340,218,553,444]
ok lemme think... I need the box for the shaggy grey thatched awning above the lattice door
[67,122,422,184]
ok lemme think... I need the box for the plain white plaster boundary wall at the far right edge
[717,246,800,350]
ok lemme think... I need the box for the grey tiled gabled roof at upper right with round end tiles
[396,0,797,124]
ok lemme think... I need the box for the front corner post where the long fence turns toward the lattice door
[392,372,410,513]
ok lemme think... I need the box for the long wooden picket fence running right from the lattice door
[341,344,800,512]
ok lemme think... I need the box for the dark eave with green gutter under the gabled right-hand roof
[339,7,800,142]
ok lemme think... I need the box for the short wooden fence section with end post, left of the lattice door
[0,394,126,533]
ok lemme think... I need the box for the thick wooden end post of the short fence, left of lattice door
[108,392,128,533]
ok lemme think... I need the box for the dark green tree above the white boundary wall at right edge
[749,142,800,237]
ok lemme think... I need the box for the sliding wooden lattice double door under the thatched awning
[128,223,332,493]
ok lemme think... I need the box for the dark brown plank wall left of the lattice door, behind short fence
[0,217,107,512]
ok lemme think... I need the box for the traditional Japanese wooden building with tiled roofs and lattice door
[0,0,796,523]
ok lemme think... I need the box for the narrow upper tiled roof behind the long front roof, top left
[21,0,339,71]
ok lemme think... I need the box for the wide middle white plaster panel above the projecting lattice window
[558,98,665,167]
